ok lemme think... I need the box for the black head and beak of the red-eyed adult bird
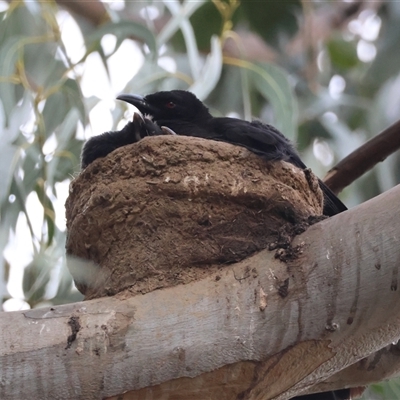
[117,90,211,123]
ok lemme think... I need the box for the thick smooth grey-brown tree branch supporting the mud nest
[0,186,400,400]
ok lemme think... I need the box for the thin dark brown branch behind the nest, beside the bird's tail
[324,120,400,194]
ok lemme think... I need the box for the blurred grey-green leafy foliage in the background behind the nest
[0,0,400,394]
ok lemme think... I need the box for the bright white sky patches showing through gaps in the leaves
[0,1,381,311]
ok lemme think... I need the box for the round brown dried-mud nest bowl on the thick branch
[66,136,323,299]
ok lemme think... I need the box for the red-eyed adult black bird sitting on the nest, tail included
[117,90,347,216]
